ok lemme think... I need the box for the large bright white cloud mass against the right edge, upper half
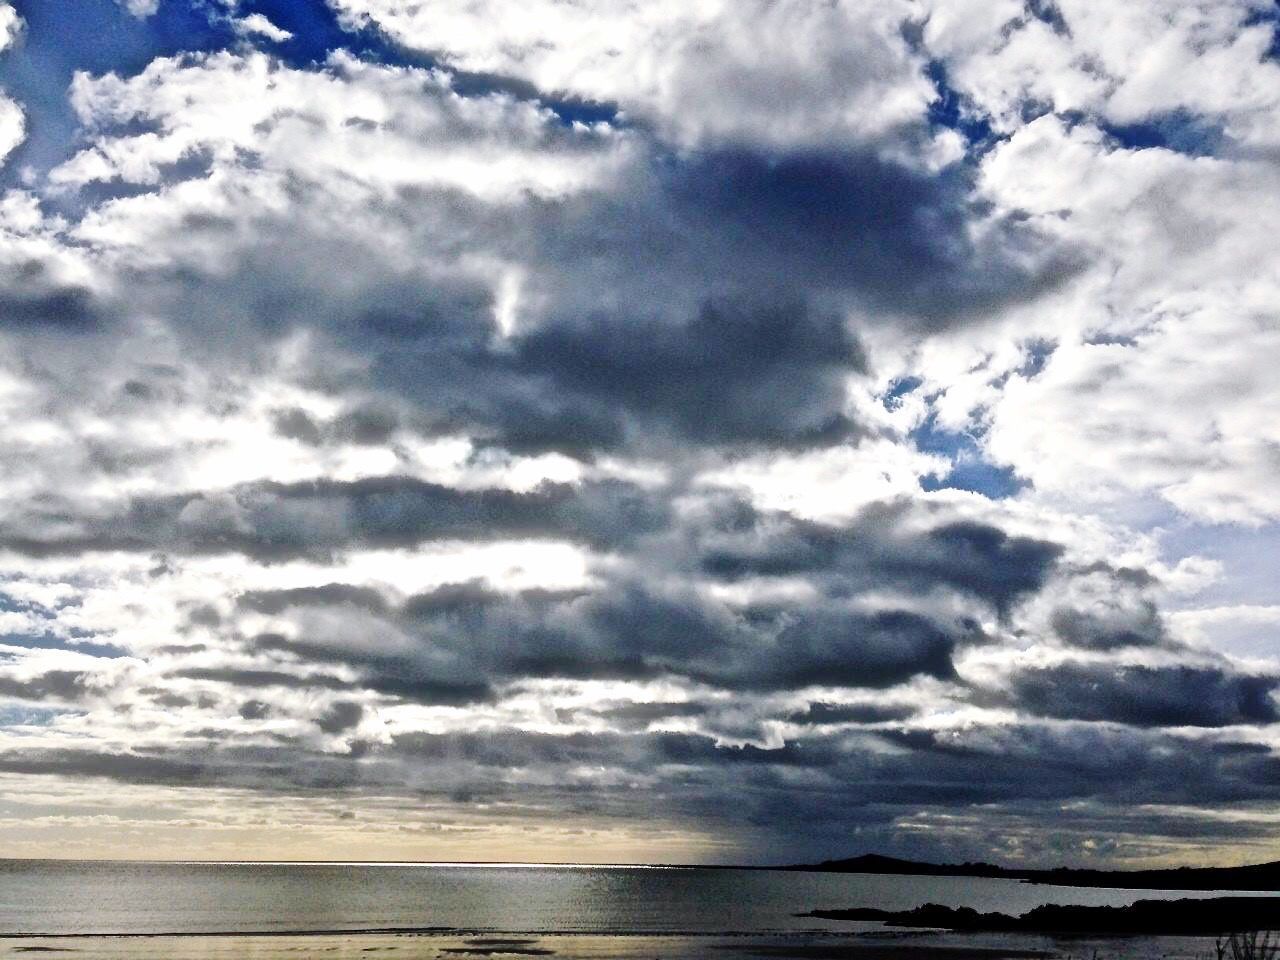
[962,118,1280,522]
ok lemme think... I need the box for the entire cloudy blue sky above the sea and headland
[0,0,1280,867]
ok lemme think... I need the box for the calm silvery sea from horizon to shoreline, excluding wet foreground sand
[0,860,1264,934]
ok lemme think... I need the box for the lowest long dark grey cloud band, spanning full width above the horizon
[0,712,1280,860]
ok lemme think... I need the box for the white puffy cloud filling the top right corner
[925,0,1280,146]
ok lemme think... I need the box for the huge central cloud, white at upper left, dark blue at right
[40,54,1079,465]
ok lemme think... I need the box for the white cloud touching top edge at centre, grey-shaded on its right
[322,0,934,148]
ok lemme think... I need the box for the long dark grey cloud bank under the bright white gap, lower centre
[227,584,973,703]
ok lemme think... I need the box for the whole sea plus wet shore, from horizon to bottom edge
[0,860,1264,960]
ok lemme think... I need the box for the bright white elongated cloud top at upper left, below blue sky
[60,54,629,206]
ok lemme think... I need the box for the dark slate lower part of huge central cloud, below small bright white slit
[327,291,867,458]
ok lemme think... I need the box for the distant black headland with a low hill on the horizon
[783,854,1280,891]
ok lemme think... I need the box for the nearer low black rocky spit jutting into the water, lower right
[800,897,1280,937]
